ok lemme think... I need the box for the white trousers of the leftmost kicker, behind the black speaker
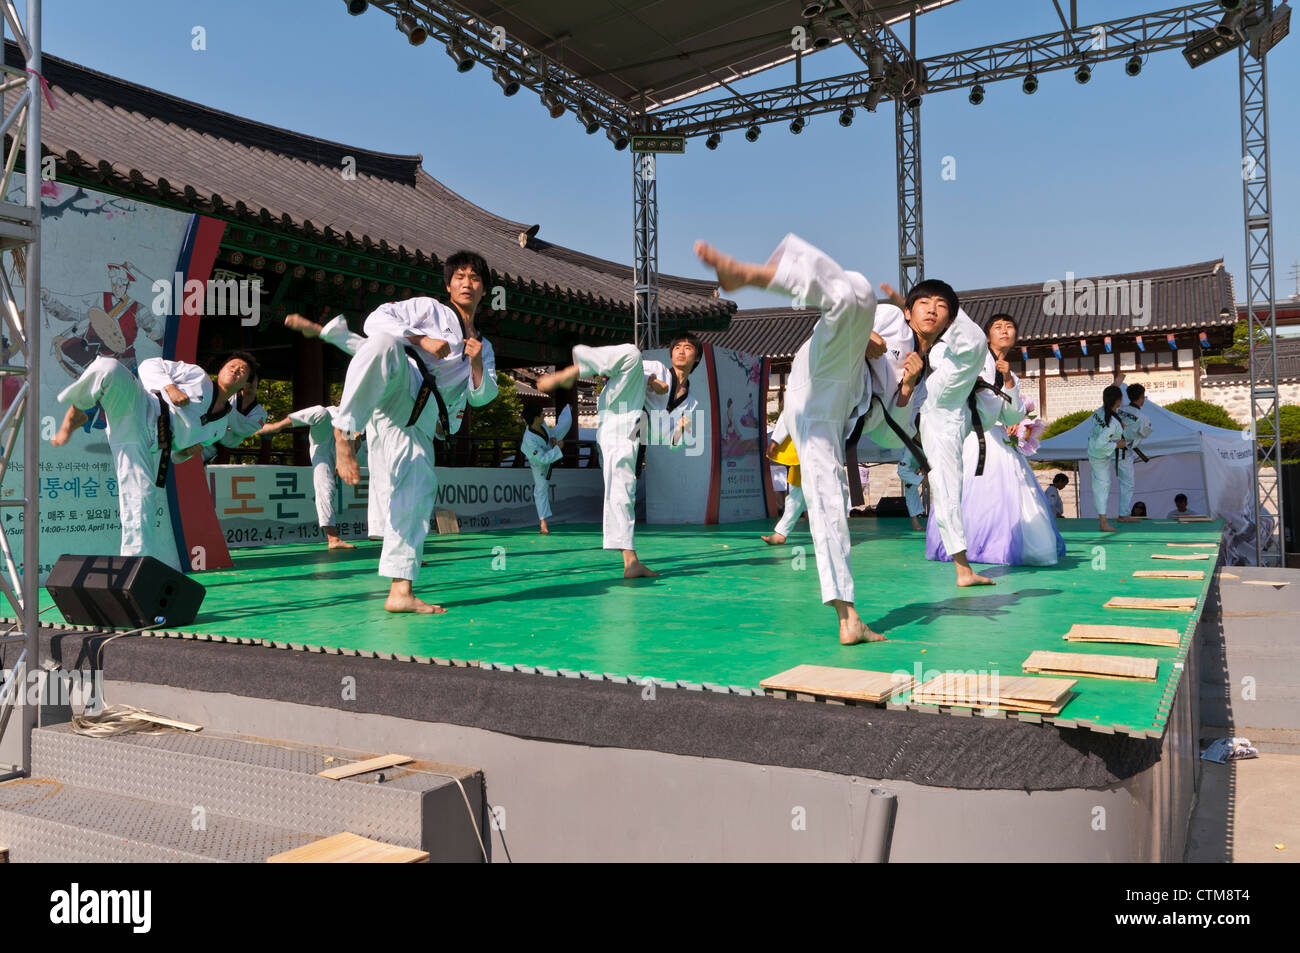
[59,358,181,571]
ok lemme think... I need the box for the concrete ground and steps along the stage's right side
[1187,567,1300,863]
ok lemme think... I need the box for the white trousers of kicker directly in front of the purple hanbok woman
[920,308,1000,554]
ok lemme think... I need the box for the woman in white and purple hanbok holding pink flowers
[922,315,1065,566]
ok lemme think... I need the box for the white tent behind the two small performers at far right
[1034,399,1274,566]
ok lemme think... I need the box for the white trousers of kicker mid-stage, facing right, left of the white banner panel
[573,345,646,550]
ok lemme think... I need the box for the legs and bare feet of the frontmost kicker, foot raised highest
[696,234,884,645]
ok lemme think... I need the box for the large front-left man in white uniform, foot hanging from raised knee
[334,252,497,612]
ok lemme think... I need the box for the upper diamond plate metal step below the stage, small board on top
[31,724,484,861]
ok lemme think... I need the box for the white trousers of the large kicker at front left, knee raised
[334,334,438,581]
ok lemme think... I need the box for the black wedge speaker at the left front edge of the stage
[46,556,207,629]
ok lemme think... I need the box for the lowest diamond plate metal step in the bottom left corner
[0,777,319,863]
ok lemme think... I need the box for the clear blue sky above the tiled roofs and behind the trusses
[44,0,1300,307]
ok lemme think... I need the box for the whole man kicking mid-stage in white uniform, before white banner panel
[537,333,701,579]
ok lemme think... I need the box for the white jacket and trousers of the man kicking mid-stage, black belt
[573,345,698,550]
